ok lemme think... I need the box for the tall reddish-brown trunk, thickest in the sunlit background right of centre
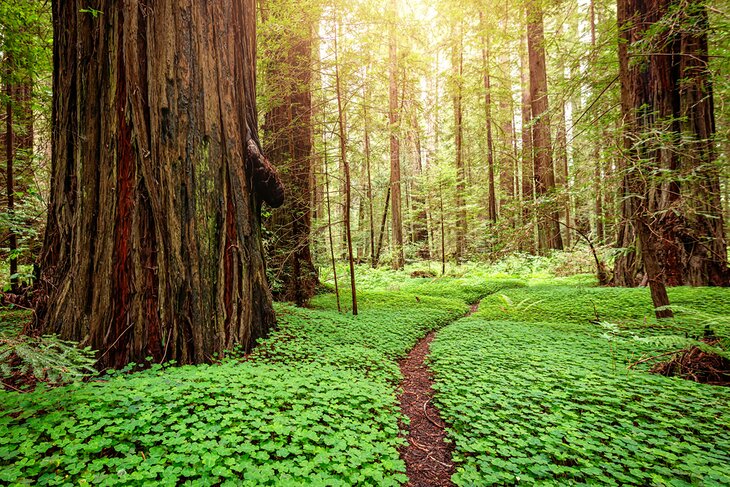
[527,0,563,253]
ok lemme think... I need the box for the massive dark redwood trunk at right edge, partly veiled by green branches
[614,0,728,285]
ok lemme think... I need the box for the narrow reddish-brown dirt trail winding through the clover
[398,304,479,487]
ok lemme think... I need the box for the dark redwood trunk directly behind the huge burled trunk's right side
[264,9,318,306]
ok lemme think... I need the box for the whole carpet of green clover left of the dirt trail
[0,274,506,485]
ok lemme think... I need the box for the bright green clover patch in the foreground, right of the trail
[431,318,730,485]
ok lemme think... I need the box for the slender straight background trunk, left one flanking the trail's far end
[451,26,467,264]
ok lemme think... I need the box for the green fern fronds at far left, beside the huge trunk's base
[0,334,96,385]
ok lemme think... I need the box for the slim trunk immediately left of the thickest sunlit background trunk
[520,37,535,253]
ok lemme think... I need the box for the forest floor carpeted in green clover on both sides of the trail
[0,266,730,485]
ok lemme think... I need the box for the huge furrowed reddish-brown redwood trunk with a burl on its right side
[39,0,283,367]
